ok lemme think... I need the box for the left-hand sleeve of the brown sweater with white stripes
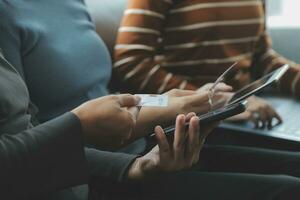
[114,0,196,93]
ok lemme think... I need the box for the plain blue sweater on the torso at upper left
[0,0,111,121]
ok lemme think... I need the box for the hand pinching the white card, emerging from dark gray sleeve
[72,94,140,148]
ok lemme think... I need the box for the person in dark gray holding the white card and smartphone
[0,48,205,200]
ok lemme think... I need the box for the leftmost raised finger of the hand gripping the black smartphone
[154,126,170,159]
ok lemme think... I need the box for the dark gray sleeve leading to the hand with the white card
[0,113,88,199]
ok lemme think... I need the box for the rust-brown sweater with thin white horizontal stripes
[114,0,300,93]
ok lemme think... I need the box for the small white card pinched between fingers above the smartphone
[136,94,169,107]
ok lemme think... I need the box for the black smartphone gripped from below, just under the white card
[149,100,247,139]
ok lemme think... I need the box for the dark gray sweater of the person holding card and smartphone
[0,49,136,200]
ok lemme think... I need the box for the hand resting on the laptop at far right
[229,96,282,129]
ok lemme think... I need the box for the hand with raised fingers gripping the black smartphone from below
[128,113,208,180]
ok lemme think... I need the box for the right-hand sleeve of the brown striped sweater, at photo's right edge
[252,6,300,98]
